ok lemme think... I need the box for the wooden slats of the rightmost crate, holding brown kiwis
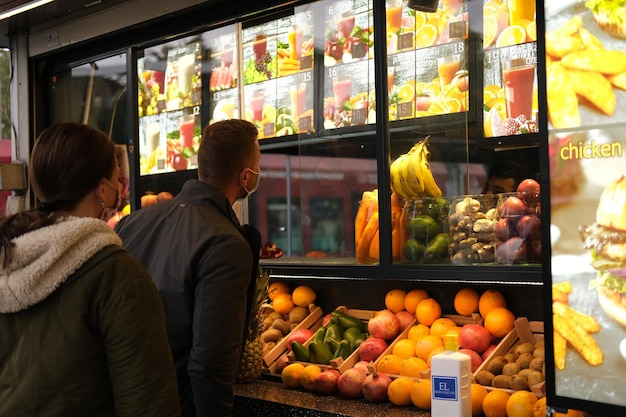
[474,317,546,398]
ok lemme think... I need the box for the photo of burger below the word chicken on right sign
[580,174,626,328]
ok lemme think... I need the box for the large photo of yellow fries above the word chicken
[545,15,626,129]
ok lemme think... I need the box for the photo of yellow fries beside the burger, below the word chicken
[552,281,604,371]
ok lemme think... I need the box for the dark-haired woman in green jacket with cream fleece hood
[0,123,180,417]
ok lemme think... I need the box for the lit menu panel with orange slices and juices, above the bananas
[386,0,469,121]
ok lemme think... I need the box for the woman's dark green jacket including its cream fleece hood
[0,218,180,417]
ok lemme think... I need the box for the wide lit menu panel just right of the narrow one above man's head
[242,6,314,139]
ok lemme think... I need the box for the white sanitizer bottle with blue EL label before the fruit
[430,334,472,417]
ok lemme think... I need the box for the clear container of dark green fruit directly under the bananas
[401,197,449,263]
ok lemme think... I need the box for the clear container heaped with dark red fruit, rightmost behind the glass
[495,180,541,264]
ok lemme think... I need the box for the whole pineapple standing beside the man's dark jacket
[237,266,270,382]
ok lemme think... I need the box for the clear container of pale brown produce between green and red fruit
[448,194,498,265]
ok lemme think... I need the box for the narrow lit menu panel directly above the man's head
[206,25,239,124]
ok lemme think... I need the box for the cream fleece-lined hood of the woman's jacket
[0,217,122,313]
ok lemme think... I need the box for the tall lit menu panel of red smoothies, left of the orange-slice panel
[323,0,376,130]
